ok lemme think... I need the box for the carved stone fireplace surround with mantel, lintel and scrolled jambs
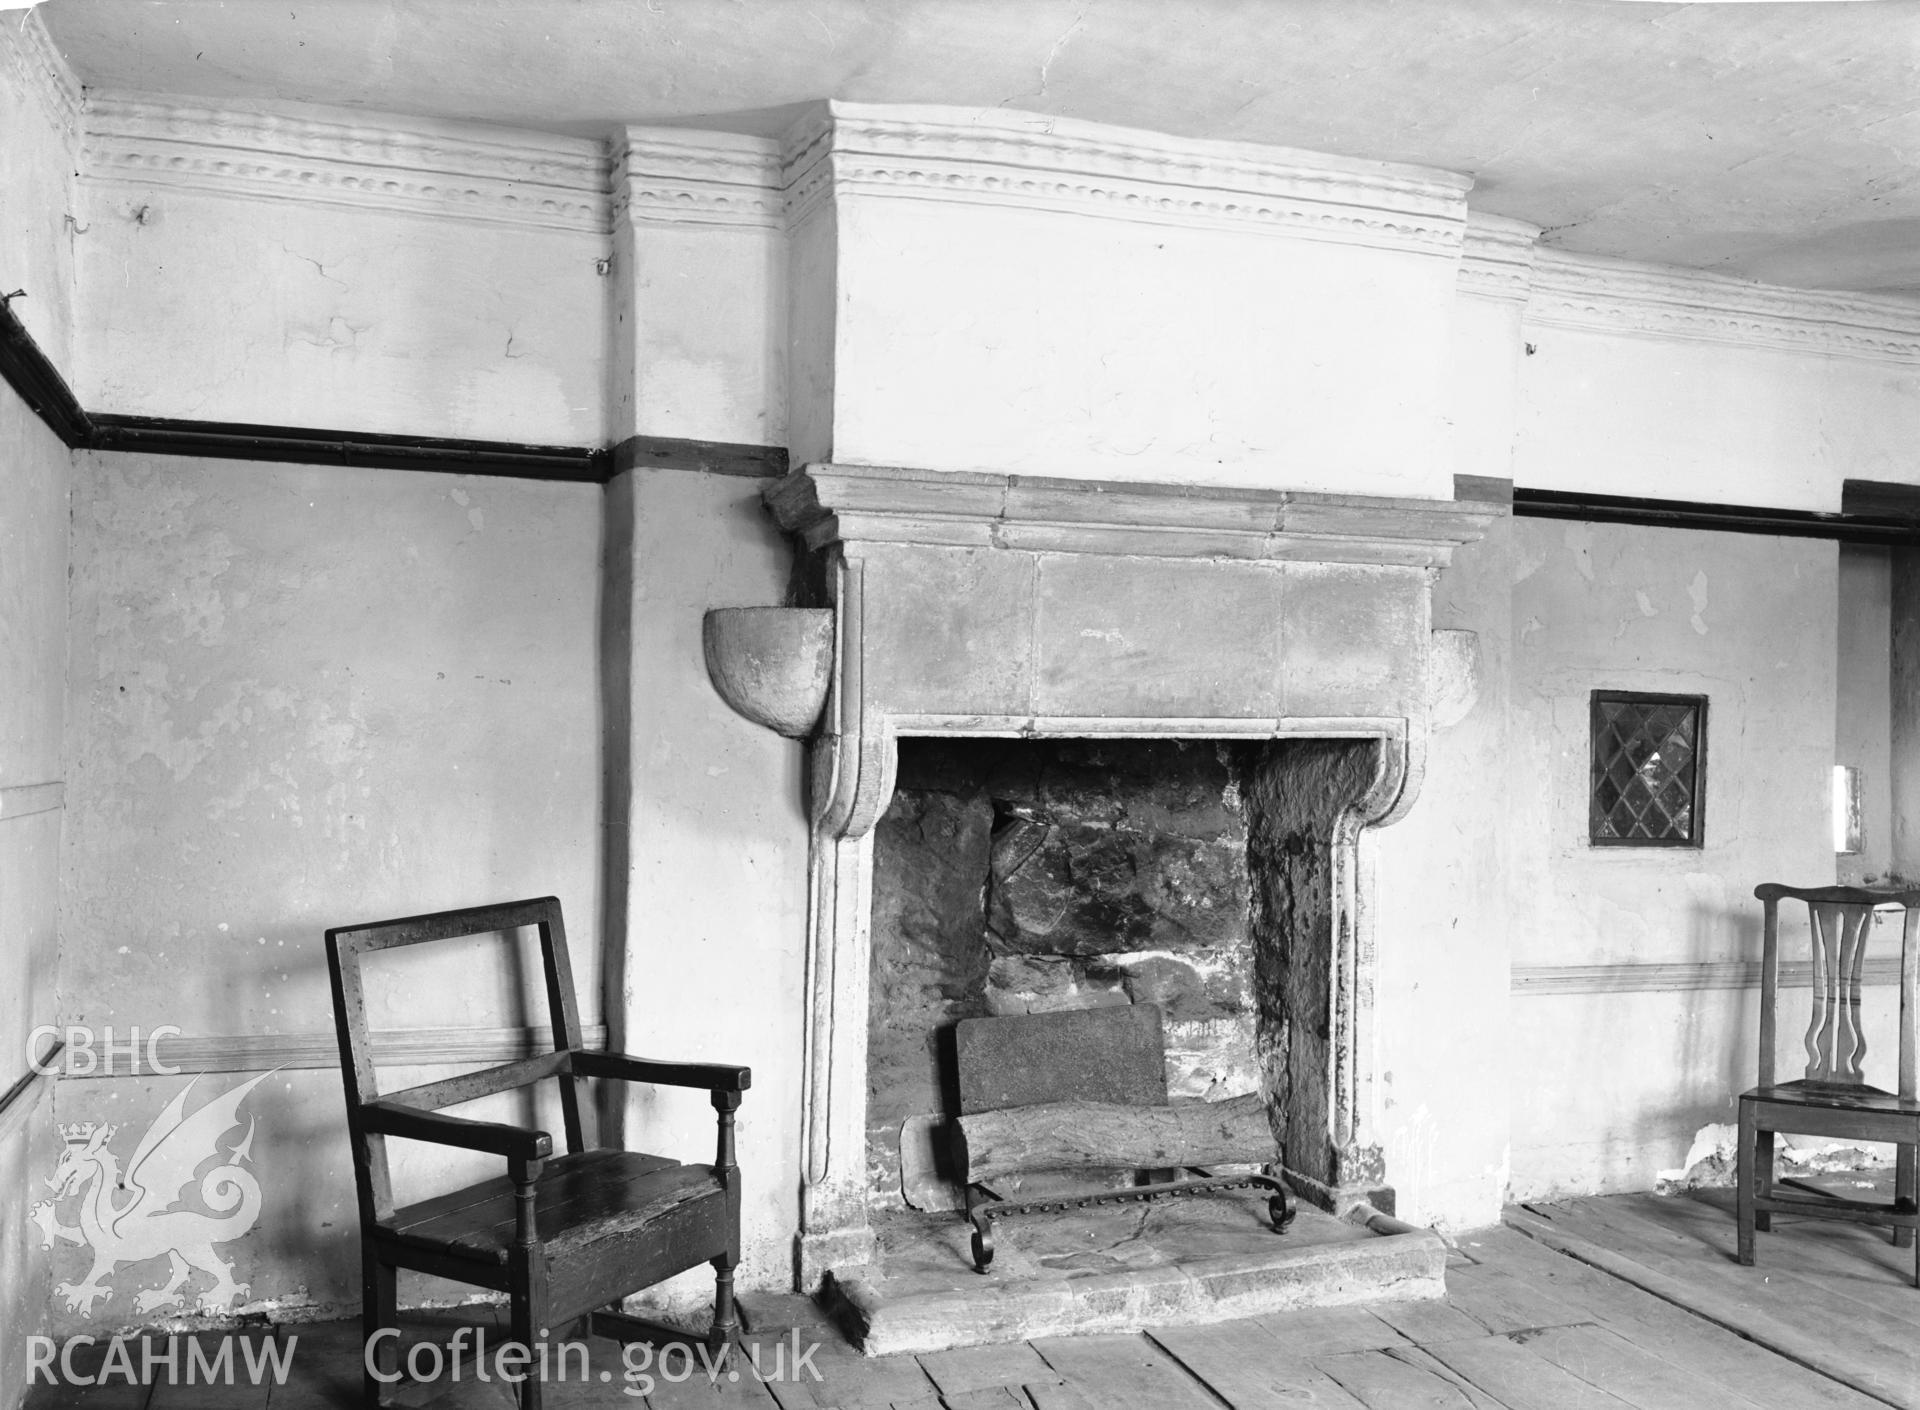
[766,463,1500,1289]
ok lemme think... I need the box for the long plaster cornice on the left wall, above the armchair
[81,98,609,232]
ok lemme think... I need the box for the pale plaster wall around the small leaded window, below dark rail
[1507,521,1835,1199]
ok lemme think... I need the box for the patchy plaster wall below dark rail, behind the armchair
[48,455,601,1331]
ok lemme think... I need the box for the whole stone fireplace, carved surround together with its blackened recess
[716,465,1496,1287]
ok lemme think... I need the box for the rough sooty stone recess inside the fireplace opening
[868,736,1392,1216]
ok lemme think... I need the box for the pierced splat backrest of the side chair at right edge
[1753,882,1920,1097]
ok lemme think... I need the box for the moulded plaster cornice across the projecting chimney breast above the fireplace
[785,102,1473,257]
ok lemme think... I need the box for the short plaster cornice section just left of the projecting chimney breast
[612,127,787,231]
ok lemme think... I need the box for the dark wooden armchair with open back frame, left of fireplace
[326,895,751,1410]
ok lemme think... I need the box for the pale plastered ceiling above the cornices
[42,0,1920,298]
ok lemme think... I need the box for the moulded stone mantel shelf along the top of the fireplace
[764,465,1500,567]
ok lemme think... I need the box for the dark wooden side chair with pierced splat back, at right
[1740,882,1920,1287]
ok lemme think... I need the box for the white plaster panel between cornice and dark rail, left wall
[73,177,607,446]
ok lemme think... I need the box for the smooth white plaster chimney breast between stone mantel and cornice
[810,194,1453,498]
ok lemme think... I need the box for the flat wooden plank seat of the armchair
[380,1151,726,1264]
